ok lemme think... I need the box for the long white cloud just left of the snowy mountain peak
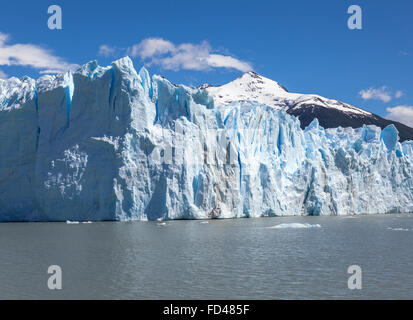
[128,38,252,72]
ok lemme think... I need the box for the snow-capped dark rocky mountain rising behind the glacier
[200,72,413,141]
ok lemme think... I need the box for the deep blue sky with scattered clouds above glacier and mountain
[0,0,413,124]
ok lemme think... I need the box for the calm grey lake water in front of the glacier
[0,215,413,299]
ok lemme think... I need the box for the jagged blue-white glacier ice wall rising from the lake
[0,58,413,221]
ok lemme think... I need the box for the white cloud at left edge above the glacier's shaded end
[0,32,79,73]
